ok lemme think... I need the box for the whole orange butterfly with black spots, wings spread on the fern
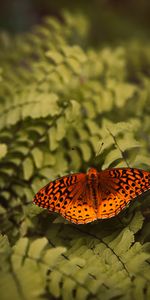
[33,168,150,224]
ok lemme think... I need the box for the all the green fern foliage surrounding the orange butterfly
[0,13,150,300]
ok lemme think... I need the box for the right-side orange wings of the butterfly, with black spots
[97,168,150,219]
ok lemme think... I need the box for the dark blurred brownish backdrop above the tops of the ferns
[0,0,150,46]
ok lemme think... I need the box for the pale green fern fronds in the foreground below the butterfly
[1,213,149,299]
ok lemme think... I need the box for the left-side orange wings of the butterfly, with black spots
[33,173,96,224]
